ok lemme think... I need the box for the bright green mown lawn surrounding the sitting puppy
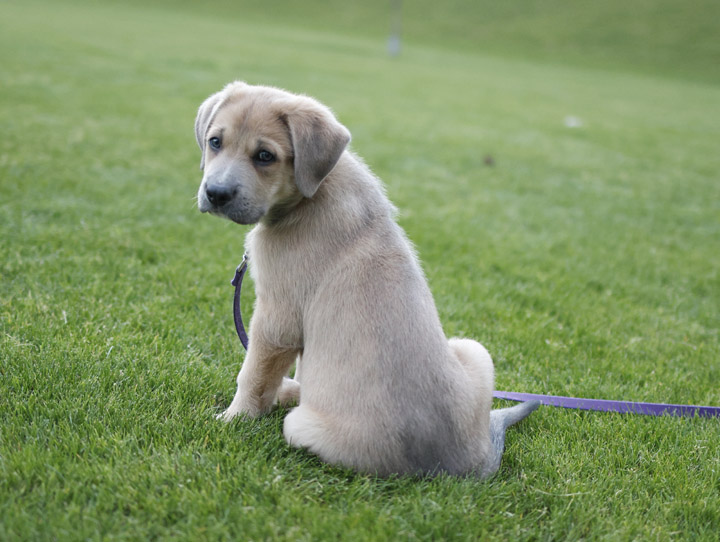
[0,1,720,541]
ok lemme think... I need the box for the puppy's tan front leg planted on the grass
[218,326,299,421]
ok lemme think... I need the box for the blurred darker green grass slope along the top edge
[122,0,720,83]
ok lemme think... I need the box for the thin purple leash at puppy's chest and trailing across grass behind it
[231,254,720,418]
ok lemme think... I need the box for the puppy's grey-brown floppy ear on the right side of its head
[284,103,350,198]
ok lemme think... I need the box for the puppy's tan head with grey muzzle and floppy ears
[195,82,350,224]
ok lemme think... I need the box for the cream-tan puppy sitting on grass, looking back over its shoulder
[195,82,537,477]
